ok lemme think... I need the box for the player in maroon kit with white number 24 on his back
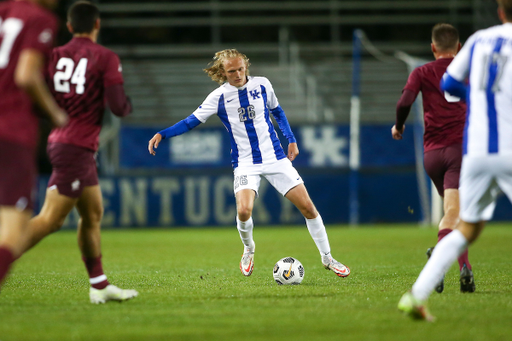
[21,1,137,303]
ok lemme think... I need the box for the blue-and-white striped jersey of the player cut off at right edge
[443,23,512,156]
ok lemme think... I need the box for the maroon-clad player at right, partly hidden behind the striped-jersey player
[391,24,475,293]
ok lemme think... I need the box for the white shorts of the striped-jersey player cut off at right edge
[459,155,512,223]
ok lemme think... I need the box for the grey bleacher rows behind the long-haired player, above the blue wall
[123,60,407,124]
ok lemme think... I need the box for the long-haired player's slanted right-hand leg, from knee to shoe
[285,184,350,277]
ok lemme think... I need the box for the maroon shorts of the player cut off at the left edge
[0,140,37,211]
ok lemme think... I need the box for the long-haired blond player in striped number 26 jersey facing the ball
[148,49,350,277]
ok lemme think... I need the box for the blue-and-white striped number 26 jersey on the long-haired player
[193,77,295,168]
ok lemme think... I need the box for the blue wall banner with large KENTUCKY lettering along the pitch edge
[38,171,430,227]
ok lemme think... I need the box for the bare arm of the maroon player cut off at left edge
[14,49,68,127]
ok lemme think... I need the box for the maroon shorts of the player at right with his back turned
[423,144,462,197]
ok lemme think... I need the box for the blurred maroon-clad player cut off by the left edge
[0,0,67,290]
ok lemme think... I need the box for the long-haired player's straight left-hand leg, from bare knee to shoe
[236,189,256,276]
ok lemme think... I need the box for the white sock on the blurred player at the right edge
[412,230,468,301]
